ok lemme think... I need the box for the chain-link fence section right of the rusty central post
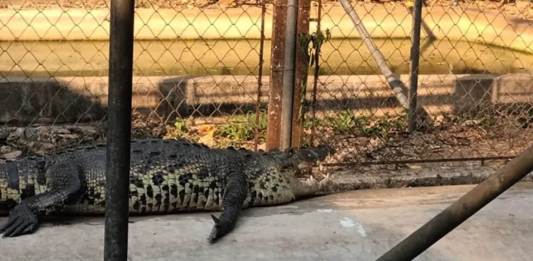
[308,1,533,169]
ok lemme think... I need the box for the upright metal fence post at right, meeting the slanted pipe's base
[407,0,423,133]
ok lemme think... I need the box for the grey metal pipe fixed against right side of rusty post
[280,0,298,150]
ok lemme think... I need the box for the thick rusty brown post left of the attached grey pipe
[266,0,287,150]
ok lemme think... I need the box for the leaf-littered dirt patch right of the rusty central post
[325,118,533,165]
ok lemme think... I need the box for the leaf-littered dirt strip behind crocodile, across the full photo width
[0,113,533,170]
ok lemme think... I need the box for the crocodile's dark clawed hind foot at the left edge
[0,204,39,237]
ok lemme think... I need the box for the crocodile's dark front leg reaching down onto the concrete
[208,173,248,243]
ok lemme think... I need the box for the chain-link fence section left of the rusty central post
[0,0,269,159]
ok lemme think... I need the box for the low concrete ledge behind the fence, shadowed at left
[0,74,533,123]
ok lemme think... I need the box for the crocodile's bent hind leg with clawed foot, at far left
[0,163,81,237]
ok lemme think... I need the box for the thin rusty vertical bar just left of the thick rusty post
[254,0,266,151]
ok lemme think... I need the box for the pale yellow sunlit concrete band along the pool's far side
[0,4,533,53]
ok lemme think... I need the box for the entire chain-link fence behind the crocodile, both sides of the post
[0,0,533,171]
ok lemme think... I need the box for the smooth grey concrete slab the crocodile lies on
[0,183,533,261]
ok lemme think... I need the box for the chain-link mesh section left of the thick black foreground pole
[0,0,109,160]
